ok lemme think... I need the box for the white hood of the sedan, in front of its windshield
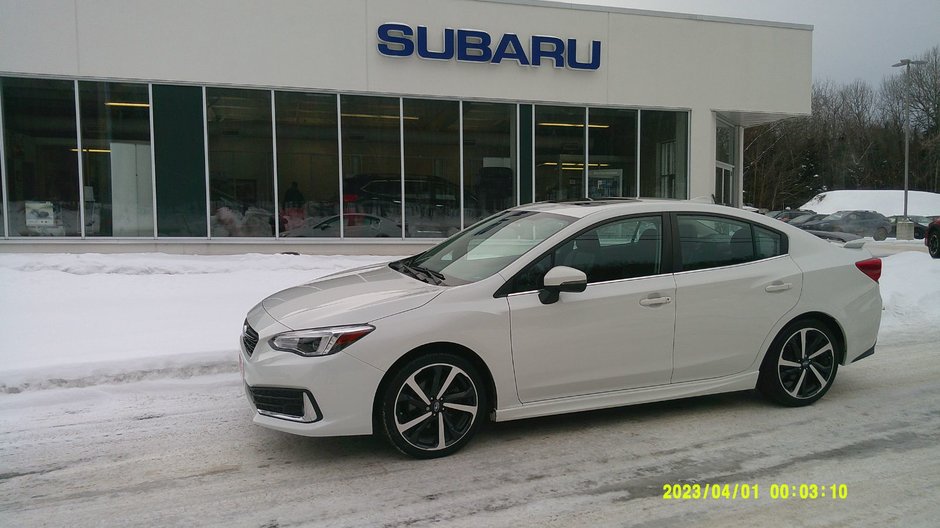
[261,264,445,330]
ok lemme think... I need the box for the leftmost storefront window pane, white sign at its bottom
[0,78,81,237]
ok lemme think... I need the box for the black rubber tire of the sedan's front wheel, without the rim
[376,352,489,459]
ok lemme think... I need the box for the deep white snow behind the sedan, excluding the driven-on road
[0,245,940,393]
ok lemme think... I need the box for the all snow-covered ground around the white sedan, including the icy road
[0,249,940,528]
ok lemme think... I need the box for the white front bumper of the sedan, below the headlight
[239,329,384,436]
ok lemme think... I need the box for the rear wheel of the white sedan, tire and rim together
[757,319,841,407]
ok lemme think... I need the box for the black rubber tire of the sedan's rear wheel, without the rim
[757,319,843,407]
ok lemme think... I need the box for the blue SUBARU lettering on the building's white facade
[377,22,601,71]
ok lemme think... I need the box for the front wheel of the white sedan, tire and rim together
[376,352,488,458]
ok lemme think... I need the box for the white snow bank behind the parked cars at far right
[800,191,940,216]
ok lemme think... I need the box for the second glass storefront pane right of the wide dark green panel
[274,92,340,237]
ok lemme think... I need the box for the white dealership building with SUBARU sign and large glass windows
[0,0,812,254]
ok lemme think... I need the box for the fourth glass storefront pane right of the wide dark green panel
[403,99,460,238]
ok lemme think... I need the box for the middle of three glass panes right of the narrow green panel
[587,108,637,198]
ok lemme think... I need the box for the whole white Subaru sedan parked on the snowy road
[239,200,881,458]
